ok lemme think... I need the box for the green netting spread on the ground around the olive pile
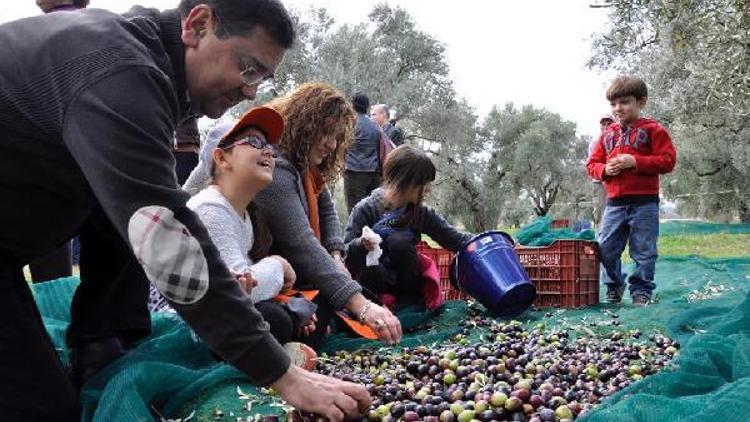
[34,252,750,421]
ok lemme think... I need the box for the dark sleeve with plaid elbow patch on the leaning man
[63,66,289,385]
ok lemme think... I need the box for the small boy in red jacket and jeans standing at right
[586,76,676,306]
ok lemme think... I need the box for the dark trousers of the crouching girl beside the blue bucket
[352,230,422,304]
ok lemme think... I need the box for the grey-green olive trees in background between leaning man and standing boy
[225,4,600,232]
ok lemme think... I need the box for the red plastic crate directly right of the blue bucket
[516,240,599,308]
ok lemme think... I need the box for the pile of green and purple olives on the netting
[312,315,679,422]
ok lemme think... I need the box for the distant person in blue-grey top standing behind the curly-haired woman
[344,94,382,212]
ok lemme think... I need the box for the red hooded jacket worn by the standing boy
[586,118,677,199]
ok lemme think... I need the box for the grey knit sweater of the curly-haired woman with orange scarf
[253,157,362,309]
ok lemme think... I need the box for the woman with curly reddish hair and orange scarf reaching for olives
[254,83,401,347]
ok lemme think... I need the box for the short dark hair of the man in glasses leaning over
[178,0,296,49]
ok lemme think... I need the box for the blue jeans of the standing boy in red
[598,202,659,297]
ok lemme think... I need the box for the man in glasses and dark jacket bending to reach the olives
[0,0,370,421]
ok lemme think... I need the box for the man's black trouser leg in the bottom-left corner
[0,257,80,422]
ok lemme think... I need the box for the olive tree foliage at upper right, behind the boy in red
[589,0,750,222]
